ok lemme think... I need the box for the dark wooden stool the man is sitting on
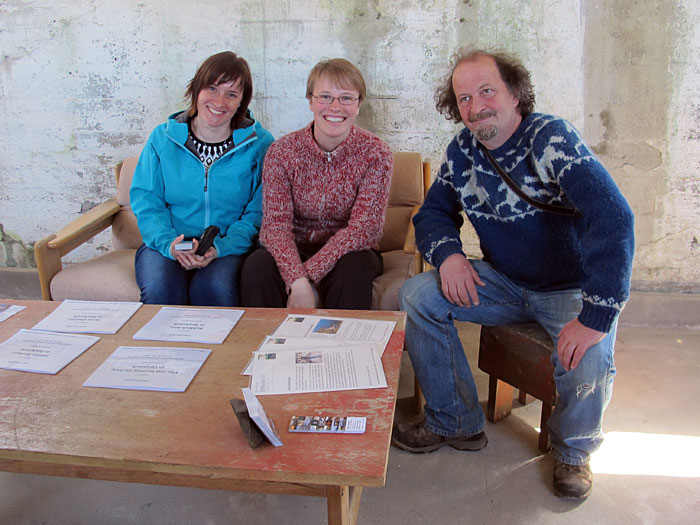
[479,323,557,452]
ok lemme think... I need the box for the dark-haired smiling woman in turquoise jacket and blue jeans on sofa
[130,51,273,306]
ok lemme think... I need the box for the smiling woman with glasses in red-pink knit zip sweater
[241,58,392,309]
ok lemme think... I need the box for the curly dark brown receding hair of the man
[435,49,535,122]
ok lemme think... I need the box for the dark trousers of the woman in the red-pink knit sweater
[240,248,384,310]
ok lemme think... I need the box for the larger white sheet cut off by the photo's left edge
[0,328,100,374]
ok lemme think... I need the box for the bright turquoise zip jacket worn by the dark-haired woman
[130,112,274,259]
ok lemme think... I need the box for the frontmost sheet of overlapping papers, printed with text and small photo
[250,344,387,395]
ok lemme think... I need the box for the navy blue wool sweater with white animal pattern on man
[414,113,634,332]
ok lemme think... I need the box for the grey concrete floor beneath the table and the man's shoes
[0,272,700,525]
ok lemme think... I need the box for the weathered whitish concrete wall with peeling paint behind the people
[0,0,700,292]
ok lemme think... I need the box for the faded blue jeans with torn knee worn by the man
[399,261,617,465]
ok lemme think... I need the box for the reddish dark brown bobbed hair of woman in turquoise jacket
[185,51,253,131]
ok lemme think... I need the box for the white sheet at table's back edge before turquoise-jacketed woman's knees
[134,306,244,345]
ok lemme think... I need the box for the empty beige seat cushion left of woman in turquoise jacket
[51,250,141,301]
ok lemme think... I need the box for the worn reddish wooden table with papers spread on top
[0,299,405,523]
